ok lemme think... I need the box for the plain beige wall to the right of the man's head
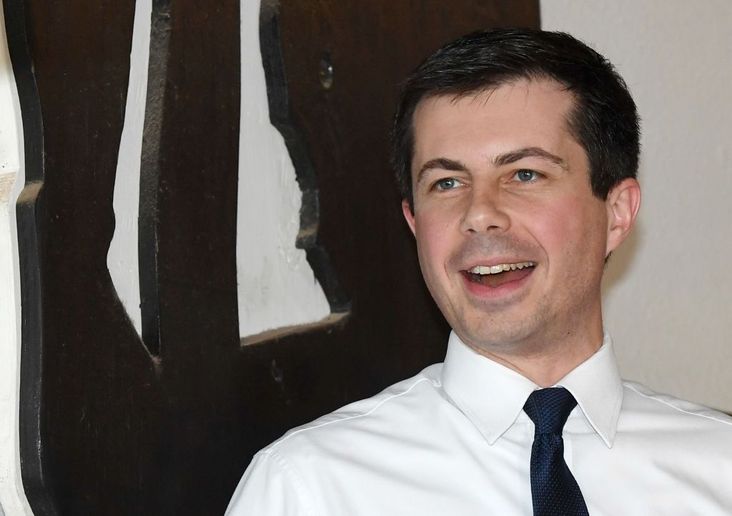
[541,0,732,411]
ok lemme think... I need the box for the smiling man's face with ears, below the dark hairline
[403,80,625,353]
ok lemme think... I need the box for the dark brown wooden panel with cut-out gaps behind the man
[4,0,538,515]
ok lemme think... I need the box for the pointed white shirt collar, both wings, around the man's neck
[442,332,623,448]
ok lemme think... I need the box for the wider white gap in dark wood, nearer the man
[236,0,330,337]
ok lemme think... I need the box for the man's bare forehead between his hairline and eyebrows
[413,79,584,169]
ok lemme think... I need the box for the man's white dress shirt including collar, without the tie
[227,334,732,516]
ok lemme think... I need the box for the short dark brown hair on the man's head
[392,29,640,210]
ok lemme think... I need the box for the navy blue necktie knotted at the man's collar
[524,388,589,516]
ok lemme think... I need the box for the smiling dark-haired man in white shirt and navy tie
[229,29,732,516]
